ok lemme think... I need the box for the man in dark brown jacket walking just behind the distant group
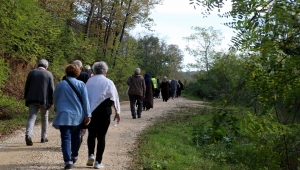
[127,68,146,119]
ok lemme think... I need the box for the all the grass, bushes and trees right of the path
[133,0,300,170]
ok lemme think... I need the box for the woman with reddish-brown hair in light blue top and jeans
[52,64,91,169]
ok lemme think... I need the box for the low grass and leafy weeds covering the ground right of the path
[131,101,299,170]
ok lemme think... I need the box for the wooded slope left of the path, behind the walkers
[0,0,189,99]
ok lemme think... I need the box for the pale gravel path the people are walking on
[0,98,201,170]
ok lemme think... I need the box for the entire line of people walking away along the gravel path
[24,59,183,169]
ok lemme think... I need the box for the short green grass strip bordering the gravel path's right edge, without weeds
[132,107,246,170]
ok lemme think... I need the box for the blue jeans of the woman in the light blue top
[59,126,80,165]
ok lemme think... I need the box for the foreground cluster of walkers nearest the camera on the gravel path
[24,59,121,169]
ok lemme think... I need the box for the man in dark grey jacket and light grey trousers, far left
[24,59,54,146]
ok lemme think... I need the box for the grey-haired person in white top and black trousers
[86,61,121,169]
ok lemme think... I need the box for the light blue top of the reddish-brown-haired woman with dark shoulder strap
[52,77,92,129]
